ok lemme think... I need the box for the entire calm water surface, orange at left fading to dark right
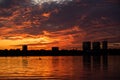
[0,56,120,80]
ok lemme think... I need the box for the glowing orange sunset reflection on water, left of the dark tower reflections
[0,56,82,77]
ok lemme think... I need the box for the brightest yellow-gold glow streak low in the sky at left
[0,36,53,49]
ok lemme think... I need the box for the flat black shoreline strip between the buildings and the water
[0,49,120,57]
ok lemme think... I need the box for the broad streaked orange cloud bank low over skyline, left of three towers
[0,26,85,49]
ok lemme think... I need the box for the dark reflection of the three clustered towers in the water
[83,55,108,72]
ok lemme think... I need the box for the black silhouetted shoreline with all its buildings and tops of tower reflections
[0,41,120,56]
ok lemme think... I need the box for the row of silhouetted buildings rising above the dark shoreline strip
[0,41,110,52]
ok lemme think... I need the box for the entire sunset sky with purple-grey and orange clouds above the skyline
[0,0,120,50]
